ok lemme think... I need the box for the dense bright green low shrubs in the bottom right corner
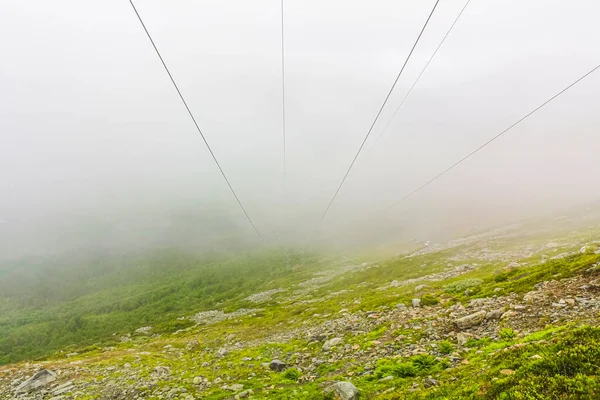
[436,327,600,400]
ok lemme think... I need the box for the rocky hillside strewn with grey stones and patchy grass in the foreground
[0,220,600,400]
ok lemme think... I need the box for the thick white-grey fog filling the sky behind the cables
[0,0,600,259]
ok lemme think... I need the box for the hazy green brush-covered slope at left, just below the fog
[0,250,312,365]
